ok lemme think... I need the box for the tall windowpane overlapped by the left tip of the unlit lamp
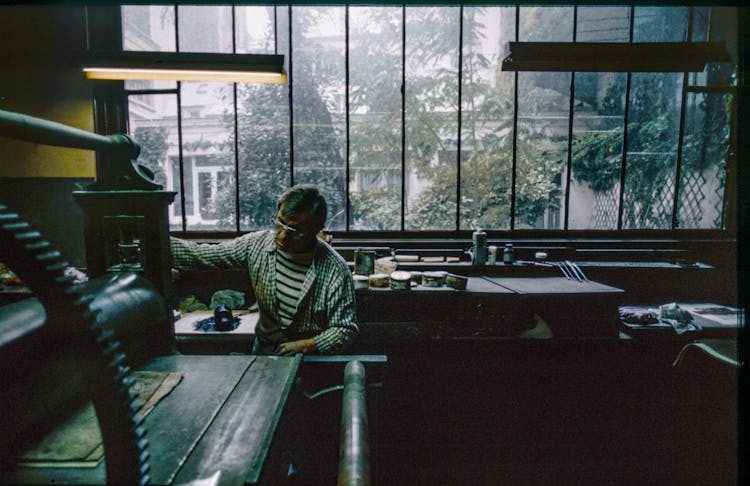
[461,7,515,229]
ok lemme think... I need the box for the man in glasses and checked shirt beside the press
[171,184,359,356]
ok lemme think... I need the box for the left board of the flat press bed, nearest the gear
[145,355,255,484]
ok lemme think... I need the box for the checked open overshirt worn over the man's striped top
[170,230,359,354]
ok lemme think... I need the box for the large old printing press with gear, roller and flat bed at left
[0,111,376,485]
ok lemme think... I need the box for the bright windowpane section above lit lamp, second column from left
[177,5,233,53]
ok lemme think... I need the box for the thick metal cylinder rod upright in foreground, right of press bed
[337,361,370,486]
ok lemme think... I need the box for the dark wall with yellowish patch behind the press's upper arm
[0,5,95,266]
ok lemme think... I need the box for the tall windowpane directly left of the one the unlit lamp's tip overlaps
[404,7,460,230]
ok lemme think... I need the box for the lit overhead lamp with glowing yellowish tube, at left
[83,51,287,84]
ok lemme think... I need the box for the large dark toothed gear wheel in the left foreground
[0,204,149,485]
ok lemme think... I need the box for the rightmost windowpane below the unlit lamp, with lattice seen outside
[677,93,733,229]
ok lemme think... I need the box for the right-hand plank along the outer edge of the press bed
[176,355,302,485]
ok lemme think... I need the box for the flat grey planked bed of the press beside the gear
[11,355,302,485]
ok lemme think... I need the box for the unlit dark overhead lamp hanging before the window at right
[501,41,732,72]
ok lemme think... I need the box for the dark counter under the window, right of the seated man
[356,276,624,340]
